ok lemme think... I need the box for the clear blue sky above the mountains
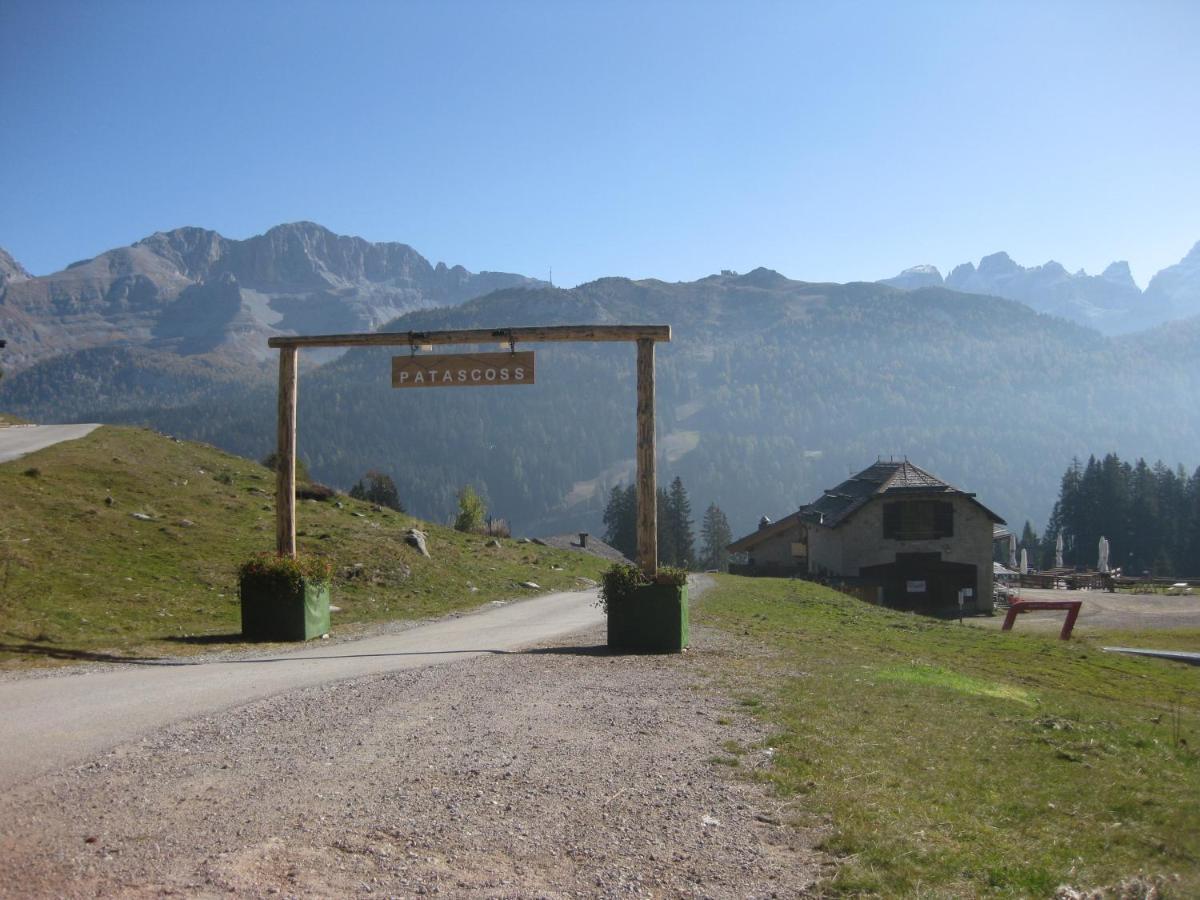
[0,0,1200,286]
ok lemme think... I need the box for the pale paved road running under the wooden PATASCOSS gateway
[0,590,604,790]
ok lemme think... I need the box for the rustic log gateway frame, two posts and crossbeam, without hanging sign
[266,325,671,576]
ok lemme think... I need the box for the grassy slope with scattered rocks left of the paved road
[0,427,604,666]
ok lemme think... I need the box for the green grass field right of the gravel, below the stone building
[694,576,1200,898]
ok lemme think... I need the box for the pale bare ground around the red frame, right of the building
[968,588,1200,633]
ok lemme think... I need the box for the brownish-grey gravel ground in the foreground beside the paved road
[0,630,832,898]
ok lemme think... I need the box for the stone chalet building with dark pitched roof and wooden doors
[730,460,1004,613]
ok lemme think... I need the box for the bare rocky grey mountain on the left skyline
[0,222,540,371]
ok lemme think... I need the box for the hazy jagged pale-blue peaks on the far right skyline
[883,244,1200,335]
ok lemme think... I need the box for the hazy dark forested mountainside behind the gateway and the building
[0,270,1200,534]
